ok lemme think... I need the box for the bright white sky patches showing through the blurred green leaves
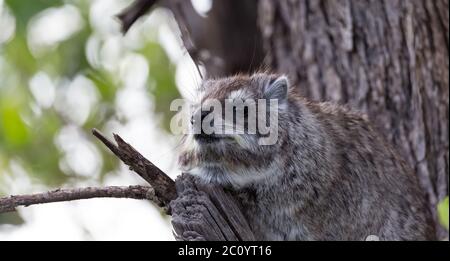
[0,0,211,240]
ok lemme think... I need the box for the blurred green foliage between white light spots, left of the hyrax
[0,0,179,224]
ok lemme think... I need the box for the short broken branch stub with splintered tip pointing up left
[92,129,177,211]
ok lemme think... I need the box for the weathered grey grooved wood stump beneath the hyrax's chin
[171,174,255,241]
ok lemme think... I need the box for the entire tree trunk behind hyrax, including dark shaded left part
[117,0,449,238]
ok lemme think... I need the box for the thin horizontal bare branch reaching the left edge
[0,186,155,214]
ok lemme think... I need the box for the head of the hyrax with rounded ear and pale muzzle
[179,74,288,185]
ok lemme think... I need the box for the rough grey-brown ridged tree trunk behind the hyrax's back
[259,0,449,235]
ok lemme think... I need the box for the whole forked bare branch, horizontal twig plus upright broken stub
[0,129,177,214]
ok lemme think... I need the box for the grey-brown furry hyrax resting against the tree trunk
[179,73,435,240]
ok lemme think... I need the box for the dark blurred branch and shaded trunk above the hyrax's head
[118,0,266,78]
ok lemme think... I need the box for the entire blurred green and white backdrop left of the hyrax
[0,0,207,240]
